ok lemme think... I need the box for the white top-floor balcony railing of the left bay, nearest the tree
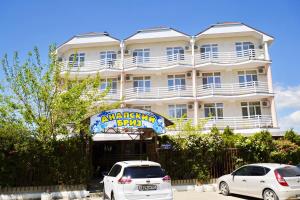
[61,59,121,72]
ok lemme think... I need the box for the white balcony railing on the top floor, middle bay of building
[124,54,192,69]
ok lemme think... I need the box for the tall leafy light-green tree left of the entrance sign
[1,45,118,139]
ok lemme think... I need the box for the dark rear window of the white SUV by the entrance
[124,166,165,178]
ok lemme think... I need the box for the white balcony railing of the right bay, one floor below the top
[197,81,269,97]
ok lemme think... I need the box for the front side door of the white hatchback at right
[229,166,250,195]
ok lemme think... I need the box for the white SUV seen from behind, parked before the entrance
[103,160,173,200]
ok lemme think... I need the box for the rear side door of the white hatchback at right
[246,166,270,197]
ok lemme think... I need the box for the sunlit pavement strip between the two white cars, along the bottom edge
[174,191,258,200]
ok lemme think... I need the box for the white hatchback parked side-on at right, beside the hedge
[217,163,300,200]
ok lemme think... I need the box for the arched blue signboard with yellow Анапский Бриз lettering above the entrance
[90,108,166,134]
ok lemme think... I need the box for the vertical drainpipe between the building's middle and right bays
[190,36,198,126]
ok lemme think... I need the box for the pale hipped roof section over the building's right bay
[196,22,274,42]
